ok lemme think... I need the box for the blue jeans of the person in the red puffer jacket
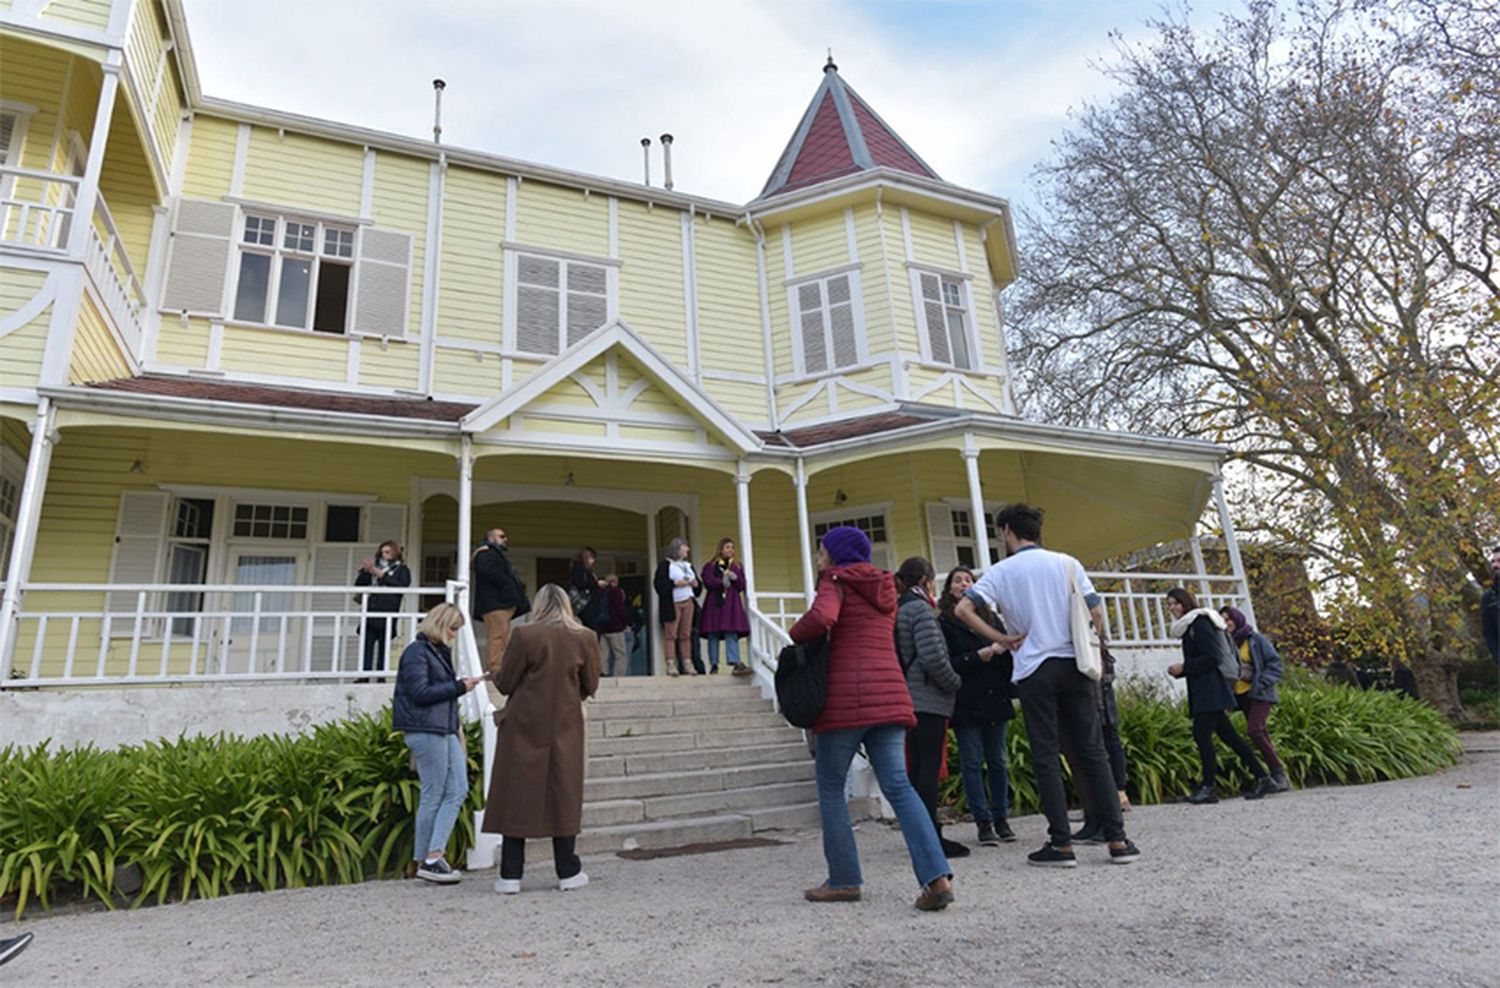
[815,724,953,889]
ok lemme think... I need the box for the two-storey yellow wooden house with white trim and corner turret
[0,0,1245,688]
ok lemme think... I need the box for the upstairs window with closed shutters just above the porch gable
[516,253,611,355]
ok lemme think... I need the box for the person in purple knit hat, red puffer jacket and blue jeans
[788,526,953,912]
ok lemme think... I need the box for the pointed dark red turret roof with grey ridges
[761,58,938,199]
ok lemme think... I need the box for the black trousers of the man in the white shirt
[1016,657,1125,847]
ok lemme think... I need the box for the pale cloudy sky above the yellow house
[185,0,1235,211]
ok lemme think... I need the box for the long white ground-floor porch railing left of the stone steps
[0,583,453,690]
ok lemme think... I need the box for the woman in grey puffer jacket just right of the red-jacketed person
[896,556,969,858]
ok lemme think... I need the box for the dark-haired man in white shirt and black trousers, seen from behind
[954,504,1140,868]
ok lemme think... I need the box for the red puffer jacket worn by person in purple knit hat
[789,562,917,735]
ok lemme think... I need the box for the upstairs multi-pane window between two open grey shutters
[234,213,354,334]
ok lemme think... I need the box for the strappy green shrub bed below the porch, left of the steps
[0,711,482,918]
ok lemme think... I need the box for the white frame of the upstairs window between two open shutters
[227,205,363,339]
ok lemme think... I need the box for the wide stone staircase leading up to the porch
[570,673,840,855]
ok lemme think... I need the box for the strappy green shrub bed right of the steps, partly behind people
[941,686,1463,816]
